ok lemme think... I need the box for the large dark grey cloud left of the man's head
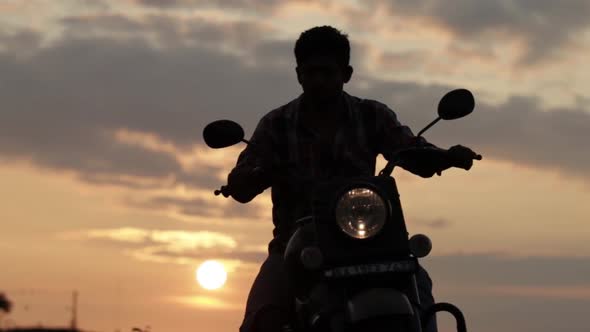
[0,16,297,139]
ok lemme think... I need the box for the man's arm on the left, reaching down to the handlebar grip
[227,116,273,203]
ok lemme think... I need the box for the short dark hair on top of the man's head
[295,25,350,66]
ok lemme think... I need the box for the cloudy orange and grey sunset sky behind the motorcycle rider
[0,0,590,332]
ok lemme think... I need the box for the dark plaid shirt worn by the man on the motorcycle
[235,92,430,249]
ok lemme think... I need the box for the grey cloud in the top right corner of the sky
[369,0,590,65]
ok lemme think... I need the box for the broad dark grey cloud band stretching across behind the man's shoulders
[0,16,590,200]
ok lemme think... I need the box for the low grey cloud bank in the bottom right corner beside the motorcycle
[421,253,590,332]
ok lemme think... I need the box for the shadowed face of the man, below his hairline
[296,56,352,104]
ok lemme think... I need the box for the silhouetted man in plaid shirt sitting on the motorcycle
[227,26,476,332]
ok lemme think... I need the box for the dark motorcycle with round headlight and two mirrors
[203,89,482,332]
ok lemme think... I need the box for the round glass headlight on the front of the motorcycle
[335,188,387,239]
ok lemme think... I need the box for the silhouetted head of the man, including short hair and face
[295,26,352,104]
